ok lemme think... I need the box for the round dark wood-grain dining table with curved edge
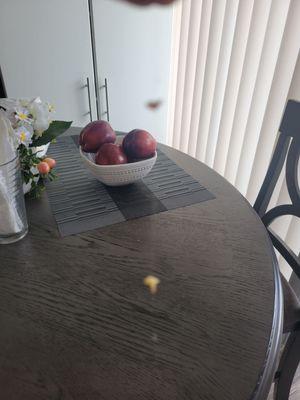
[0,130,283,400]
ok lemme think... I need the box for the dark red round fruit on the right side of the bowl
[122,129,156,159]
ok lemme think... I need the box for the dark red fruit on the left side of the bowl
[79,121,116,153]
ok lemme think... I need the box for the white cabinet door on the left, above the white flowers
[0,0,96,126]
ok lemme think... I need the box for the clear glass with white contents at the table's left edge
[0,156,28,244]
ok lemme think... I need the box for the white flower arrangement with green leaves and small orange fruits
[0,97,72,197]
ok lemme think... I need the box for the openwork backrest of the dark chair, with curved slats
[253,100,300,279]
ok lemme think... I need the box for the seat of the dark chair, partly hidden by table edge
[281,274,300,333]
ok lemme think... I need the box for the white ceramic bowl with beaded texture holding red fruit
[79,147,157,186]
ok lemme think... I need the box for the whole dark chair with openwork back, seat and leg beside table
[254,100,300,400]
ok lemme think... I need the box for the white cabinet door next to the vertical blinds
[93,0,173,142]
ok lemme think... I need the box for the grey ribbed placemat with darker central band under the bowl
[46,136,214,236]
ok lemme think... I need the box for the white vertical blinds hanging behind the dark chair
[167,0,300,276]
